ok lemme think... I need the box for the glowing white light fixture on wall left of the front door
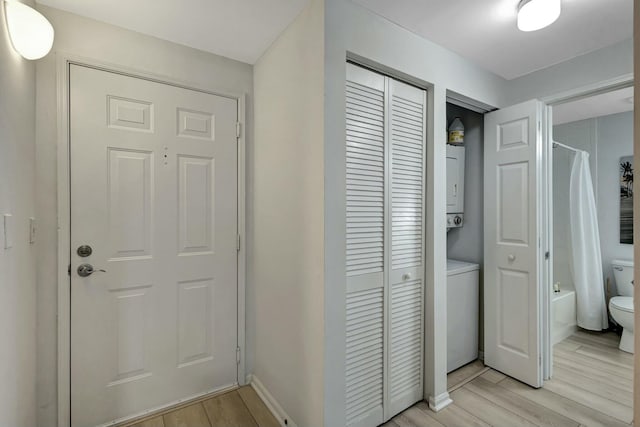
[0,0,53,59]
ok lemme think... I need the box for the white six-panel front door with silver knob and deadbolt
[69,65,238,427]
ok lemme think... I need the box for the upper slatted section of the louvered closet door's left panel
[346,81,385,276]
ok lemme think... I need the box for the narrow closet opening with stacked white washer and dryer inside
[446,103,485,384]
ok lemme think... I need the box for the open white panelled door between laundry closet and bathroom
[484,101,544,387]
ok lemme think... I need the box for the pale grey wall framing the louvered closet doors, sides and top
[324,0,506,425]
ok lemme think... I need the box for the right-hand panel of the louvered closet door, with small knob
[385,80,426,416]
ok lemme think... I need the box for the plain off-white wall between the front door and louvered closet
[250,0,324,427]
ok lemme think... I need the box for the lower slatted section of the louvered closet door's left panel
[345,288,384,425]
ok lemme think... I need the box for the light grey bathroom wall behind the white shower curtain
[553,112,633,294]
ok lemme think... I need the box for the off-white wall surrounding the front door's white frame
[33,6,255,426]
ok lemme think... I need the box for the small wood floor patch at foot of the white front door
[121,386,280,427]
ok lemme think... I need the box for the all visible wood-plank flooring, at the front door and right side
[117,332,633,427]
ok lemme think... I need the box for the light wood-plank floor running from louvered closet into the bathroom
[385,331,633,427]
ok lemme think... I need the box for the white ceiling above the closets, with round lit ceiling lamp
[353,0,633,79]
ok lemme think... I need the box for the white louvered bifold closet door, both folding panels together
[345,64,426,427]
